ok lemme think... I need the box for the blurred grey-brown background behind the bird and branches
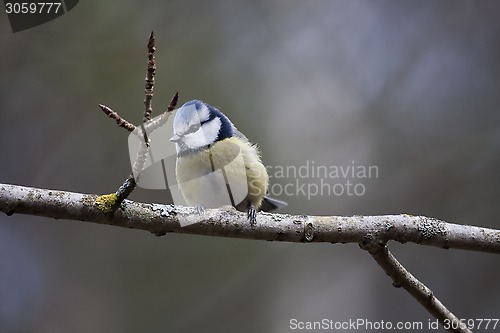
[0,0,500,333]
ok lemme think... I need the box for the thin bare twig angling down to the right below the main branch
[360,241,472,333]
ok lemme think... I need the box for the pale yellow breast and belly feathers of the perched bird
[176,137,269,211]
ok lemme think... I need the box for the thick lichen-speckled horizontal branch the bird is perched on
[0,184,500,254]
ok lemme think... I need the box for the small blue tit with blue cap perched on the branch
[170,100,286,224]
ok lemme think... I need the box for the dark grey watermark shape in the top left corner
[4,0,79,32]
